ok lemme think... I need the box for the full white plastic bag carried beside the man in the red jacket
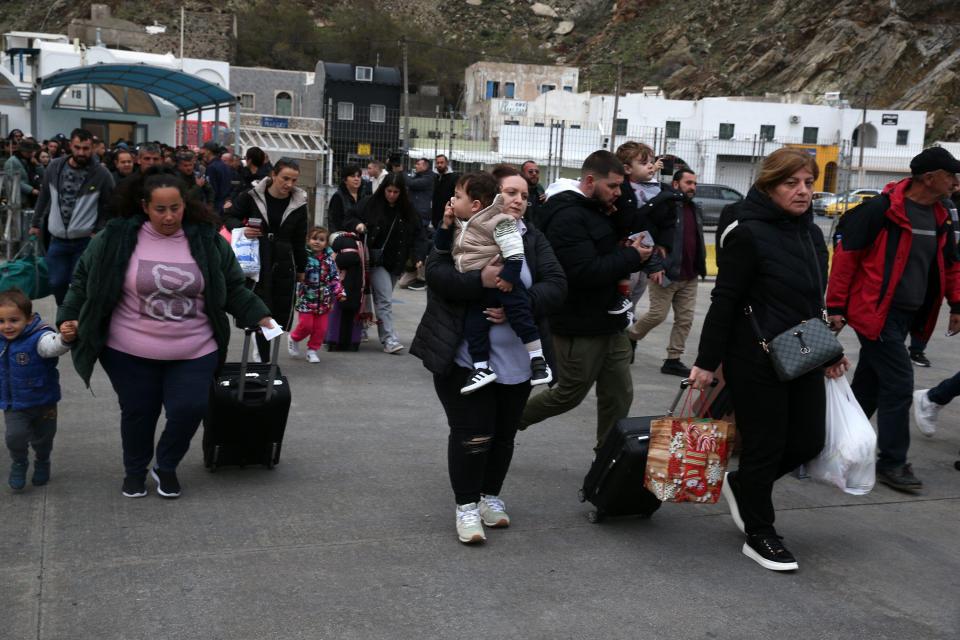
[806,376,877,496]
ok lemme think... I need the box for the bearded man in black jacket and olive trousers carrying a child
[520,151,653,444]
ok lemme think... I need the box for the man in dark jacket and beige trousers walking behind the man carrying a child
[627,169,707,378]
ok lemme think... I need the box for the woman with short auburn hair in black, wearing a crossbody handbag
[690,148,849,571]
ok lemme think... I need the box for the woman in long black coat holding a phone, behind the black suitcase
[224,158,307,362]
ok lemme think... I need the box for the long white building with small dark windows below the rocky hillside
[488,90,927,191]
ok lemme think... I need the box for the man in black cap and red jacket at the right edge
[826,147,960,492]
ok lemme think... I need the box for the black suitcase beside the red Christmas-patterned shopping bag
[580,416,661,522]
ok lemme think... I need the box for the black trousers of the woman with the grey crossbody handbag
[723,360,826,534]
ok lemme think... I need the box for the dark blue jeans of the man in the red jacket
[850,308,915,469]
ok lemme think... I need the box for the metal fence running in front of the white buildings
[312,108,923,222]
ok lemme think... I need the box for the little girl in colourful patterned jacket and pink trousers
[287,227,346,362]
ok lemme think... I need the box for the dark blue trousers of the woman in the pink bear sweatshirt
[100,347,219,476]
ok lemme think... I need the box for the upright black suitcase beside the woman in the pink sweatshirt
[203,329,290,471]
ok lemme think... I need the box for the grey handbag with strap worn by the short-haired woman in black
[745,305,843,382]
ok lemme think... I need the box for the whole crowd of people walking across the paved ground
[0,129,960,570]
